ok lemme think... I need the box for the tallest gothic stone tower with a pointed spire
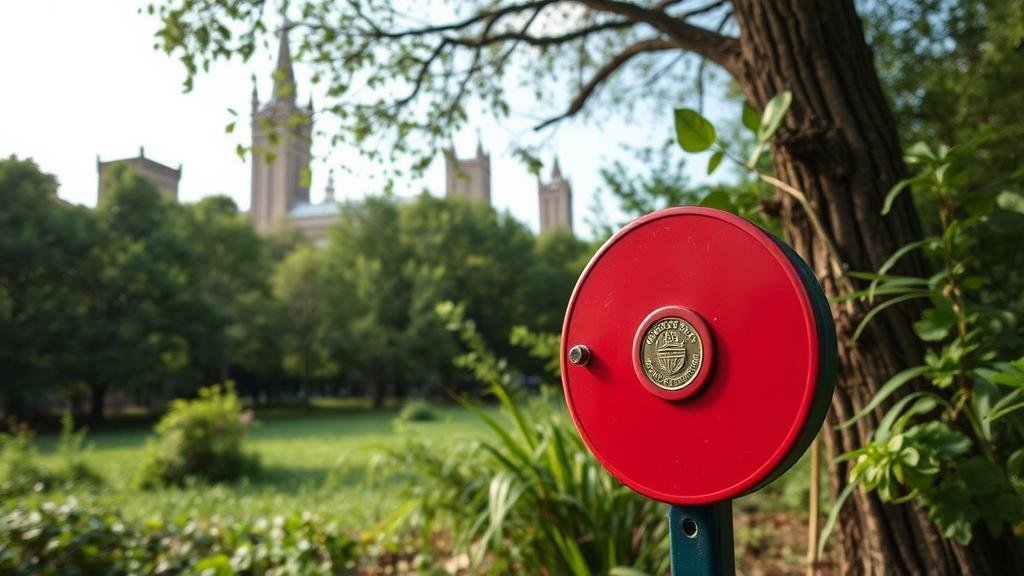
[249,24,312,232]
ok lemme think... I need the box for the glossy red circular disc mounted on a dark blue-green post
[561,207,834,504]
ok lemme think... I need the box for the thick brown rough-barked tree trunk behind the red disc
[733,0,1024,574]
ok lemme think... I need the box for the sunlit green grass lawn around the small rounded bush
[30,403,495,532]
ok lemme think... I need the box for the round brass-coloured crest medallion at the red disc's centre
[640,317,703,390]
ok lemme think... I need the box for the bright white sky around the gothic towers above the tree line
[0,0,737,235]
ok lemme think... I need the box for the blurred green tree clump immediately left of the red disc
[319,195,565,402]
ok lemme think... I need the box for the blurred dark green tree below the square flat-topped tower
[74,163,226,420]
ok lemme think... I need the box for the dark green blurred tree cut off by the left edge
[0,156,91,418]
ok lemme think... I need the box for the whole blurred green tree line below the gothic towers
[0,157,592,419]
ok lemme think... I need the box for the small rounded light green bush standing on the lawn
[142,384,259,486]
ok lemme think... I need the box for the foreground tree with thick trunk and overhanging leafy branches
[151,0,1024,574]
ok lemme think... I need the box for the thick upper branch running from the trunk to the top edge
[580,0,740,77]
